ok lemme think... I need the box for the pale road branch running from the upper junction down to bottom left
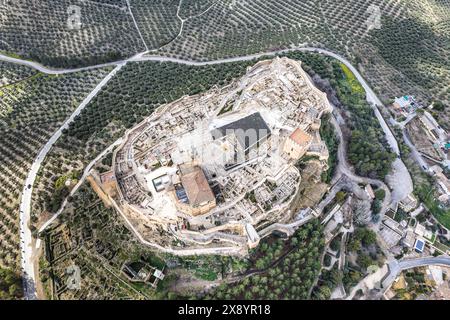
[19,63,124,299]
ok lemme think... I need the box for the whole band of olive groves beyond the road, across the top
[0,0,450,110]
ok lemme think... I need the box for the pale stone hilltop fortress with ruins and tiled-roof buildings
[96,58,332,254]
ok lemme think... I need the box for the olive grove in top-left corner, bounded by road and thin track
[0,0,144,67]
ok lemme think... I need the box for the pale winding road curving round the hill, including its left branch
[4,47,412,299]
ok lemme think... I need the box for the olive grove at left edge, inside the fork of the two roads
[0,65,107,267]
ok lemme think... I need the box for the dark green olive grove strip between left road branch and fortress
[32,58,252,218]
